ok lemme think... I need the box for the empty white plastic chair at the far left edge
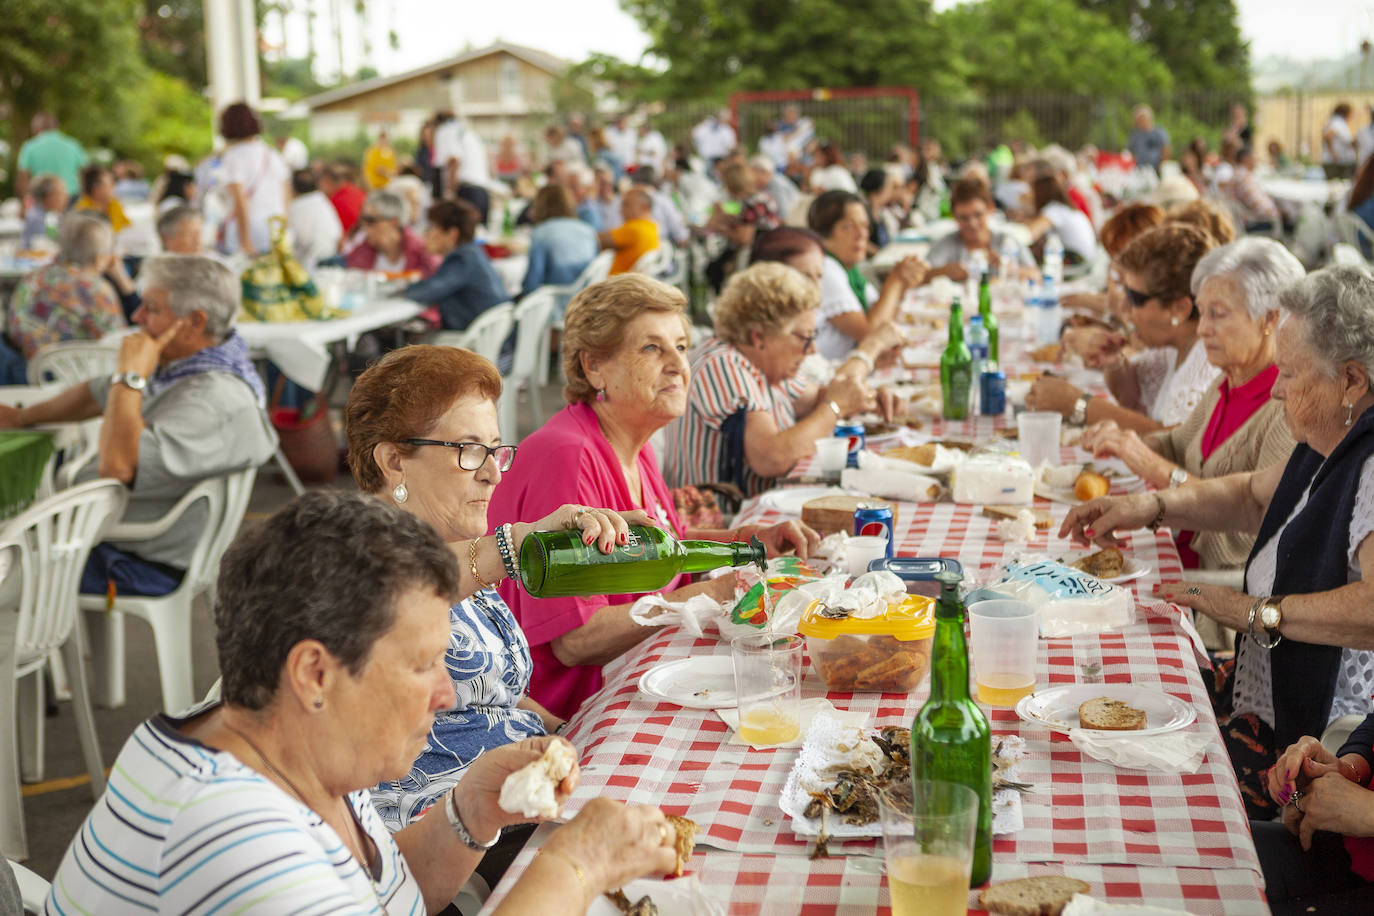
[0,481,129,860]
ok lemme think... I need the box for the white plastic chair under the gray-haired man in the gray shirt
[80,467,257,713]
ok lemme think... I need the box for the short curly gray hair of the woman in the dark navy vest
[1279,266,1374,376]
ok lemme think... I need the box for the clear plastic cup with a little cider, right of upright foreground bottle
[969,599,1040,706]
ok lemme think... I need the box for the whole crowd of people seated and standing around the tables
[13,89,1374,912]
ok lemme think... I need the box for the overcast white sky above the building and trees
[281,0,1374,81]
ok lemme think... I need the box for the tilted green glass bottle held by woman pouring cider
[519,525,767,597]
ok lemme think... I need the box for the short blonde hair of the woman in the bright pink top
[563,273,690,404]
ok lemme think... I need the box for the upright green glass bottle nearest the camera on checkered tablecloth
[911,571,992,887]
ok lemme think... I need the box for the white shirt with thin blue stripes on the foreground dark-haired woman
[43,706,425,916]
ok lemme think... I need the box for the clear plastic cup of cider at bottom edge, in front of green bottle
[878,780,978,916]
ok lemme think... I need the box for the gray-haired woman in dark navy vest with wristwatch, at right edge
[1061,266,1374,820]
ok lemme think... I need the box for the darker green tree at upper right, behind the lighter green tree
[1079,0,1250,94]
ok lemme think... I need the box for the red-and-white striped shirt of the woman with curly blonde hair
[664,338,807,496]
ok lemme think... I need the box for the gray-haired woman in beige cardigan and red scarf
[1081,236,1305,574]
